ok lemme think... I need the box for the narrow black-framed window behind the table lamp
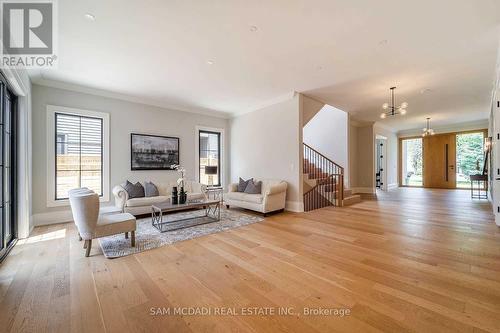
[198,130,221,186]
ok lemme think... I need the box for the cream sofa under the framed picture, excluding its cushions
[113,181,206,216]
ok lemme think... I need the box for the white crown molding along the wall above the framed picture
[31,75,231,119]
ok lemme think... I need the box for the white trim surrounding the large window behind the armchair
[46,105,110,207]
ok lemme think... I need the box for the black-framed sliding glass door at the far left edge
[0,81,17,258]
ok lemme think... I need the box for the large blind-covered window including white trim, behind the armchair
[47,106,109,207]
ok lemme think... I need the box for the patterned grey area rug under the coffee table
[99,209,263,259]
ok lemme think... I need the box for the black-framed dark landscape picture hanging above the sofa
[130,133,180,171]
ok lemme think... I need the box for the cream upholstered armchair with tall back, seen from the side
[69,189,136,257]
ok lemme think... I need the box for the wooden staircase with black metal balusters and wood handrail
[303,143,361,212]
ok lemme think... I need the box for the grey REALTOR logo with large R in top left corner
[0,0,57,68]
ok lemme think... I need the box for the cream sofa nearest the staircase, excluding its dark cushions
[224,179,288,215]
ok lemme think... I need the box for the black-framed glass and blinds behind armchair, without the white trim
[55,112,103,200]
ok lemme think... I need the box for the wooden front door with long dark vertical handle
[423,133,457,188]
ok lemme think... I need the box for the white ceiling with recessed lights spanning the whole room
[32,0,500,130]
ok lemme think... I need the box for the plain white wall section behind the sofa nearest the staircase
[230,94,303,211]
